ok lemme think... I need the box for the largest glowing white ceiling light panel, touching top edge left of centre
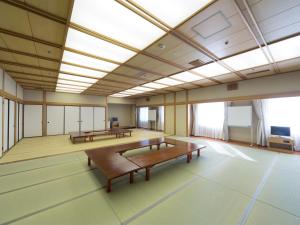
[71,0,165,50]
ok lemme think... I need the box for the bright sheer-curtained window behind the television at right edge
[264,97,300,150]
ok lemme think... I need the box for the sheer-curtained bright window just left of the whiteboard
[193,102,225,139]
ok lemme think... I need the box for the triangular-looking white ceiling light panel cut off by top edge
[132,0,212,28]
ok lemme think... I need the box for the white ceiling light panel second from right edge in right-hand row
[223,49,268,71]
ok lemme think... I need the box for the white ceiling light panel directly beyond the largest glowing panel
[65,28,137,63]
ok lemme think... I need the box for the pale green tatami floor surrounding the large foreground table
[0,138,300,225]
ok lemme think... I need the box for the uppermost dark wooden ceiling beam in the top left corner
[0,0,67,25]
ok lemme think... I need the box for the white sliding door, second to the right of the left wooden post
[65,106,80,134]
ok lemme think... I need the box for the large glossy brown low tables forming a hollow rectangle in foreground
[85,138,205,192]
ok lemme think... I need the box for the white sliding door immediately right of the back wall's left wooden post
[47,106,64,135]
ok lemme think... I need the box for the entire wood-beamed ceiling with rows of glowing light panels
[0,0,300,97]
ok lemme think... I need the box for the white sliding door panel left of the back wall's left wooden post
[24,105,42,137]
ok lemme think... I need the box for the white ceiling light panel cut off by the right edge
[269,35,300,62]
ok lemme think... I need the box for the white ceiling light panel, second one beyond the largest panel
[62,50,119,72]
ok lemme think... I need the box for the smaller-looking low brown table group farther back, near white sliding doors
[69,128,132,143]
